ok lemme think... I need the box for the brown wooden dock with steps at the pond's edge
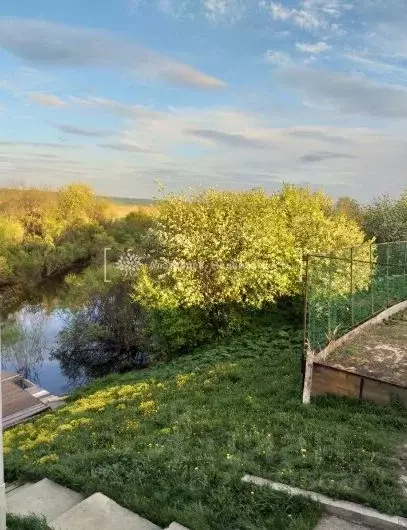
[1,371,63,429]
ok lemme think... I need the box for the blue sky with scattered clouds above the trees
[0,0,407,202]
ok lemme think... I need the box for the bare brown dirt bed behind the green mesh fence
[324,311,407,387]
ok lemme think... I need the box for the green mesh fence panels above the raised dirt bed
[305,241,407,352]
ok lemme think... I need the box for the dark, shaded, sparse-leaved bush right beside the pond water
[52,274,148,381]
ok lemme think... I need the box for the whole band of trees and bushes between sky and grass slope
[0,184,407,377]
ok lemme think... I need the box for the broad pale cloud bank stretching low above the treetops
[0,97,407,199]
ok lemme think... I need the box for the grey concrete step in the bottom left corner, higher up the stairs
[6,478,83,521]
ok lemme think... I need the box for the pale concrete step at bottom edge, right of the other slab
[50,493,161,530]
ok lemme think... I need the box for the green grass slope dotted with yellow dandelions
[5,318,407,530]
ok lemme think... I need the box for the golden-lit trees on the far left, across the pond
[0,184,151,317]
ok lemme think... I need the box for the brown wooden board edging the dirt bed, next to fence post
[312,364,361,398]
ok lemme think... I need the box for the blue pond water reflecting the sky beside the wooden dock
[2,307,79,396]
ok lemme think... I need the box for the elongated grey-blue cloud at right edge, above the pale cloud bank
[280,69,407,119]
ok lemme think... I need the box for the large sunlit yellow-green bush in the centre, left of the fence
[134,186,364,351]
